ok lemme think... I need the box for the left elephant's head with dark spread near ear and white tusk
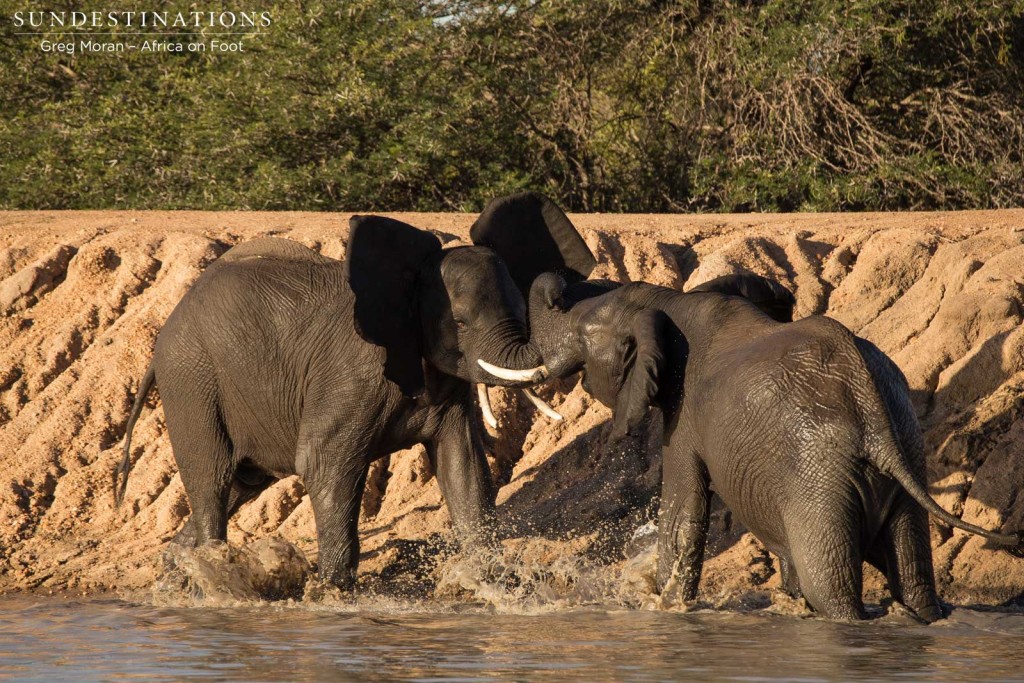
[345,211,548,396]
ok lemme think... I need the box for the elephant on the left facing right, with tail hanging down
[118,216,542,588]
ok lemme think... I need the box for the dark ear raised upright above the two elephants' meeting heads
[469,193,597,300]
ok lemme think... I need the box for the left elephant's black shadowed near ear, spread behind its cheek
[345,216,441,396]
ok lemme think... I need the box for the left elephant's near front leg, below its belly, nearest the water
[302,452,369,591]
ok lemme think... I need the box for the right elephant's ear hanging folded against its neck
[611,309,684,439]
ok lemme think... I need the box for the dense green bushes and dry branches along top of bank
[0,0,1024,212]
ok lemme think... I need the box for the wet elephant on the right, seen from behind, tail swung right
[480,193,1022,622]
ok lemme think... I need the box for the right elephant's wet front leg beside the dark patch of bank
[657,449,711,600]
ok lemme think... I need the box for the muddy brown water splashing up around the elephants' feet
[146,523,809,615]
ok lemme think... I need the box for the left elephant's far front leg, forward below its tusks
[425,409,495,544]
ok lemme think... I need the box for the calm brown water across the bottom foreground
[0,597,1024,681]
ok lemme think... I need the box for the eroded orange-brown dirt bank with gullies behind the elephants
[0,211,1024,604]
